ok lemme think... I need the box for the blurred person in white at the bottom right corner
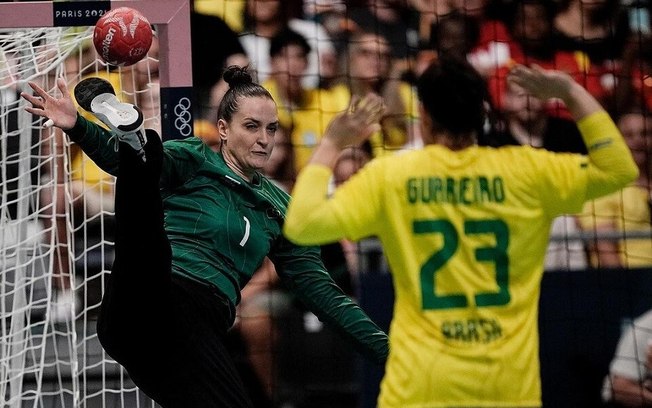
[602,310,652,408]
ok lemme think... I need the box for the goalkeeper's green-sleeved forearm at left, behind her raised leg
[65,115,118,176]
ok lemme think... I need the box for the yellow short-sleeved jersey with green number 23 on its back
[296,145,587,408]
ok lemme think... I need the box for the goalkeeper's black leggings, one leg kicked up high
[97,131,252,408]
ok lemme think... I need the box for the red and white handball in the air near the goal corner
[93,7,154,66]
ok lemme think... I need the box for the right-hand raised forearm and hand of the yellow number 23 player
[507,65,638,199]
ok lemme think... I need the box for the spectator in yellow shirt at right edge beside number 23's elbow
[580,108,652,268]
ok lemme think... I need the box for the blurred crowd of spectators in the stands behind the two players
[180,0,652,405]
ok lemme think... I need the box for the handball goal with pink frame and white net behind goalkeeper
[0,0,192,408]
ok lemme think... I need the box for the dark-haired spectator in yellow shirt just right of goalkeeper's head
[263,29,349,174]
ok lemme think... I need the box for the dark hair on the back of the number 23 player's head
[417,57,491,136]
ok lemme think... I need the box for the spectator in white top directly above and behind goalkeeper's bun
[240,0,336,88]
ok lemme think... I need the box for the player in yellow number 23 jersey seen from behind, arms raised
[284,59,638,408]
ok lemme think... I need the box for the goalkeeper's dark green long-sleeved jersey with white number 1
[68,116,388,361]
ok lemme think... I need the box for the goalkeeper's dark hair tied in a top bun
[217,65,274,122]
